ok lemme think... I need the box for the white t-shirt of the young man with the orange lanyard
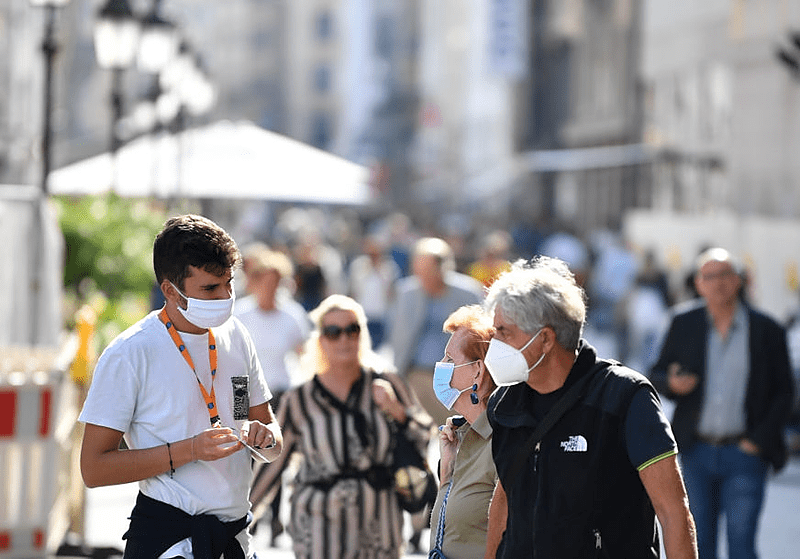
[79,311,272,556]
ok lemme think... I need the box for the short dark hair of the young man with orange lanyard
[153,215,241,289]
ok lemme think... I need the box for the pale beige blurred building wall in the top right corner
[643,0,800,217]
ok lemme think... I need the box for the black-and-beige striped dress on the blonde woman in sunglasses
[250,371,432,559]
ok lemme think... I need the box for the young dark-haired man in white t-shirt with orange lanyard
[80,215,283,559]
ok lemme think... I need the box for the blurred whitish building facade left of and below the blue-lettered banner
[414,0,515,217]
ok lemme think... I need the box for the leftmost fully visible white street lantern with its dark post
[94,0,139,157]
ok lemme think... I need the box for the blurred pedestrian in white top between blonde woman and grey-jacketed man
[349,235,400,349]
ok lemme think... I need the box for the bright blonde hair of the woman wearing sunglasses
[300,294,390,375]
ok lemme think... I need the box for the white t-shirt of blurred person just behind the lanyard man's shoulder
[236,307,306,392]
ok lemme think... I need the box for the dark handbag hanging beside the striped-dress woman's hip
[392,425,437,513]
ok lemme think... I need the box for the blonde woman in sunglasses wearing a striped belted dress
[251,295,432,559]
